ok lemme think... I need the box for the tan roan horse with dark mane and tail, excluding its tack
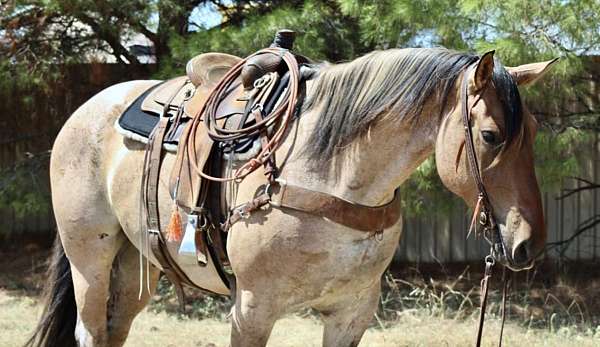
[28,48,554,347]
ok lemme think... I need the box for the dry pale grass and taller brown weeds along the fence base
[0,252,600,347]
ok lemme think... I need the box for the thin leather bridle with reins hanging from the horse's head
[460,64,511,347]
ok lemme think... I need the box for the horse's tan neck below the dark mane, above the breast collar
[280,112,438,206]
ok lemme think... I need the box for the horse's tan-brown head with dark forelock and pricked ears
[435,52,554,270]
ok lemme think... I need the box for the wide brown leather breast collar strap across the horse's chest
[229,181,401,232]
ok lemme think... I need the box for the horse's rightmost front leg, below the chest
[319,281,380,347]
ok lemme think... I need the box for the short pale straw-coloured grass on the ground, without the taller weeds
[0,290,600,347]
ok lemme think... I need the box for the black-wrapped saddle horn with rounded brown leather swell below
[242,29,296,90]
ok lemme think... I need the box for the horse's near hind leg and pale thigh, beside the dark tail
[50,128,126,347]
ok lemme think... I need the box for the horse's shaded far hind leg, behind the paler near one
[108,241,160,347]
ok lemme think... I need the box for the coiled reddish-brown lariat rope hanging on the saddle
[182,48,300,182]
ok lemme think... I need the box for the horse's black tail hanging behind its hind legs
[25,235,77,347]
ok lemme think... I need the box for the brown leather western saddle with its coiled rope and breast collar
[141,30,400,309]
